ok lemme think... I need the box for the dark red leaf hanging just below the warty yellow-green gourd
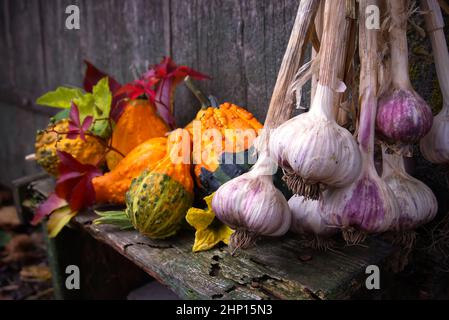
[55,151,101,211]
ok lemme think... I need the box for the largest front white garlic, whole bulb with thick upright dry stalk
[269,0,361,199]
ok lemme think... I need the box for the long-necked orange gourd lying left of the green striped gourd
[92,137,167,204]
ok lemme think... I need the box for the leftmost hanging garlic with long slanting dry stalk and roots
[212,0,319,250]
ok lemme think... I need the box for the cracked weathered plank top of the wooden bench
[32,179,394,300]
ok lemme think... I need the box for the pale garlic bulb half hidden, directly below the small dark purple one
[382,147,438,231]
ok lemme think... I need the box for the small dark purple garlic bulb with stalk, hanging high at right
[376,0,433,144]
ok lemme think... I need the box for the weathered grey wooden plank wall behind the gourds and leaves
[0,0,442,185]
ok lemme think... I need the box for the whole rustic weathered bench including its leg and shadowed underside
[12,176,395,299]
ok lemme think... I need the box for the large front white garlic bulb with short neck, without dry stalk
[269,84,361,199]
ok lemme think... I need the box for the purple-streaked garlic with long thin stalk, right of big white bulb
[322,0,398,243]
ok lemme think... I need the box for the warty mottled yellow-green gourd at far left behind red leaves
[35,119,106,176]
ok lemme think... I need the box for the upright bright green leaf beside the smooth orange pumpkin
[92,77,112,138]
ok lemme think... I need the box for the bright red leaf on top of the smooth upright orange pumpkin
[118,57,210,128]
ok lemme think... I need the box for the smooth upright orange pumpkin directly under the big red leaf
[106,99,169,170]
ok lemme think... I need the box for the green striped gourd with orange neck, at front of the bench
[126,129,193,239]
